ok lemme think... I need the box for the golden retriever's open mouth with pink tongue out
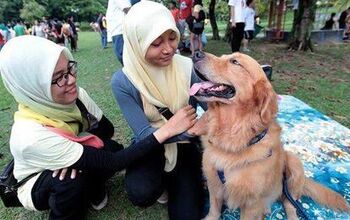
[190,70,236,99]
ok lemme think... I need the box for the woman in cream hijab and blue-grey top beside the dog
[112,1,205,220]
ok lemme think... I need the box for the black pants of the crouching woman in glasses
[32,142,122,220]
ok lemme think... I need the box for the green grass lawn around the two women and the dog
[0,32,350,220]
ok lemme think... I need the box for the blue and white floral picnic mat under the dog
[206,95,350,220]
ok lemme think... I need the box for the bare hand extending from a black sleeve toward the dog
[153,105,197,143]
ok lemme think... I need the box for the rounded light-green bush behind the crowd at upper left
[20,0,46,23]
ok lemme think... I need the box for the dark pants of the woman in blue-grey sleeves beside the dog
[125,144,204,220]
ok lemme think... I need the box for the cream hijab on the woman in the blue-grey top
[123,1,192,171]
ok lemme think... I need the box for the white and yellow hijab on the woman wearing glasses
[0,35,82,134]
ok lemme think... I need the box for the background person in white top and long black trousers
[228,0,246,52]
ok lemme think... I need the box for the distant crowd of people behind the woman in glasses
[0,15,78,52]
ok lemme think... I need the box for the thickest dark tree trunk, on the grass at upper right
[289,0,316,52]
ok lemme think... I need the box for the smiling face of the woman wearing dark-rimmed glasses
[51,53,78,105]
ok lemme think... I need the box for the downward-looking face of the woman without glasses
[145,30,177,67]
